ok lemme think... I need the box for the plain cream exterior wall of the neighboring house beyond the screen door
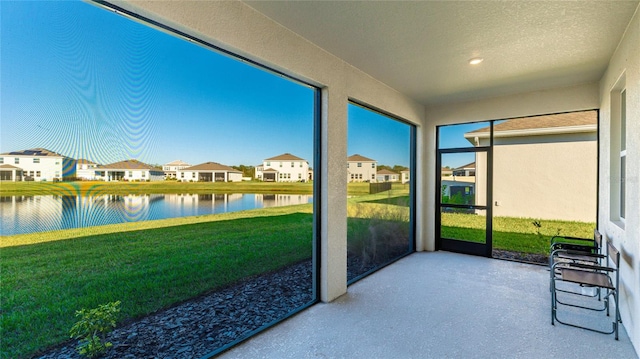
[476,132,598,222]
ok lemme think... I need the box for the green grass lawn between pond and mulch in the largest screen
[0,213,313,358]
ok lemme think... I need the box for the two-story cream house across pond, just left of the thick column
[255,153,311,182]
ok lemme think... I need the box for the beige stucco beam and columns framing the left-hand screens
[116,1,424,301]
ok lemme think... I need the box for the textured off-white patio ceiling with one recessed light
[245,0,640,105]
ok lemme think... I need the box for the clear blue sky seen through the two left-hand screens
[0,1,409,166]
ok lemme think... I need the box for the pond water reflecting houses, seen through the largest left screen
[0,193,313,236]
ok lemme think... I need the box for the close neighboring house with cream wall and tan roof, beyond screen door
[464,111,598,222]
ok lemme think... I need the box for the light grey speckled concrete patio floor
[220,252,638,359]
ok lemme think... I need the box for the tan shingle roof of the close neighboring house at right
[465,111,598,137]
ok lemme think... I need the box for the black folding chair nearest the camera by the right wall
[551,242,622,340]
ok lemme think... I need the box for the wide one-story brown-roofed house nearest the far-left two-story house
[96,160,164,182]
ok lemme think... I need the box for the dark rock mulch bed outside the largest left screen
[38,261,313,358]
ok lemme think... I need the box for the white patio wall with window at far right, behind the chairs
[598,7,640,354]
